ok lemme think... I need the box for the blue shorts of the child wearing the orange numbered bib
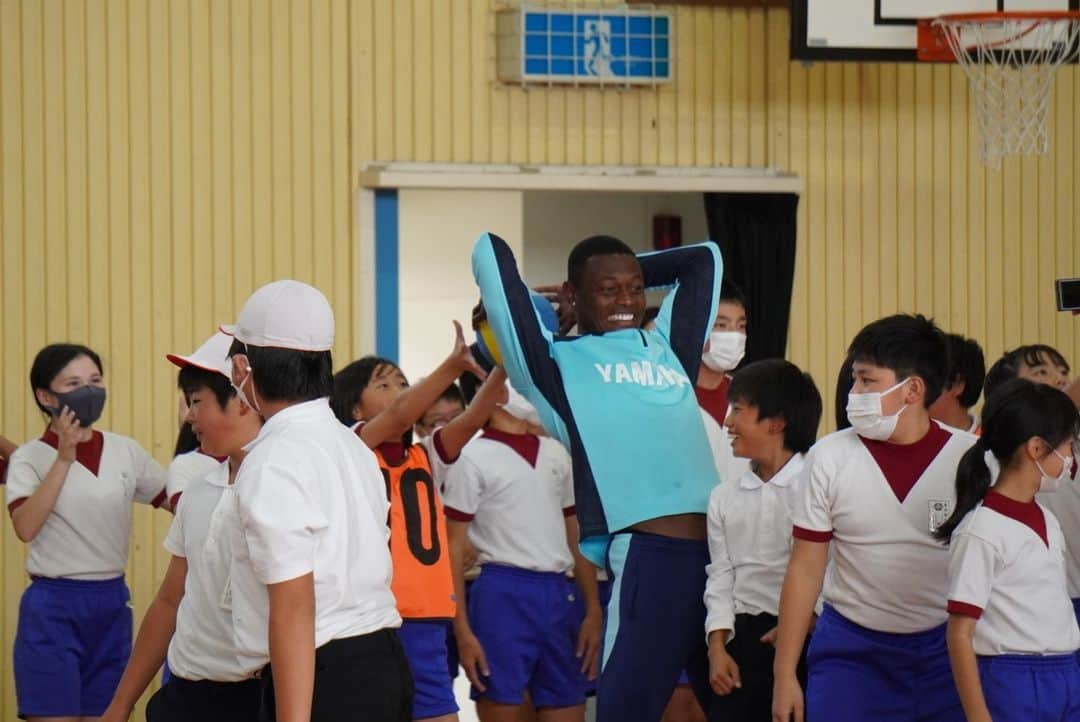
[397,619,458,720]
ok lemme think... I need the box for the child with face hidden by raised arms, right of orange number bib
[444,382,603,722]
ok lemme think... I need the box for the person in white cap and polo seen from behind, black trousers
[230,281,413,722]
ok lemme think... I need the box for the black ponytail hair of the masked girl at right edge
[934,379,1080,543]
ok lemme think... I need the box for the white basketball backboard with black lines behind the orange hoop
[792,0,1080,62]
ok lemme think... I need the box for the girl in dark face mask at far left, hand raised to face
[6,343,165,720]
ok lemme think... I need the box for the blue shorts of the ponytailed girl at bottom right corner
[978,654,1080,722]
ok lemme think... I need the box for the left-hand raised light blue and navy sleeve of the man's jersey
[472,233,569,441]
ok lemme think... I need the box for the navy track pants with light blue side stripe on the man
[596,532,712,722]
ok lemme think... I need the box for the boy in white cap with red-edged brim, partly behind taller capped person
[102,331,262,722]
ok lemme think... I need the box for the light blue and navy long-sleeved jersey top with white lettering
[472,233,723,567]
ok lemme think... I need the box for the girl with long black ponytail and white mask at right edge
[937,380,1080,722]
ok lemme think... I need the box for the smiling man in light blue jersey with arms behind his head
[472,234,723,722]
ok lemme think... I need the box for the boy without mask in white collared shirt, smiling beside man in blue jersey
[705,358,822,722]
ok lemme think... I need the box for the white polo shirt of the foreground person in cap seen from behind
[228,398,401,672]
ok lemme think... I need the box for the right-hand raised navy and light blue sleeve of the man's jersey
[637,242,724,379]
